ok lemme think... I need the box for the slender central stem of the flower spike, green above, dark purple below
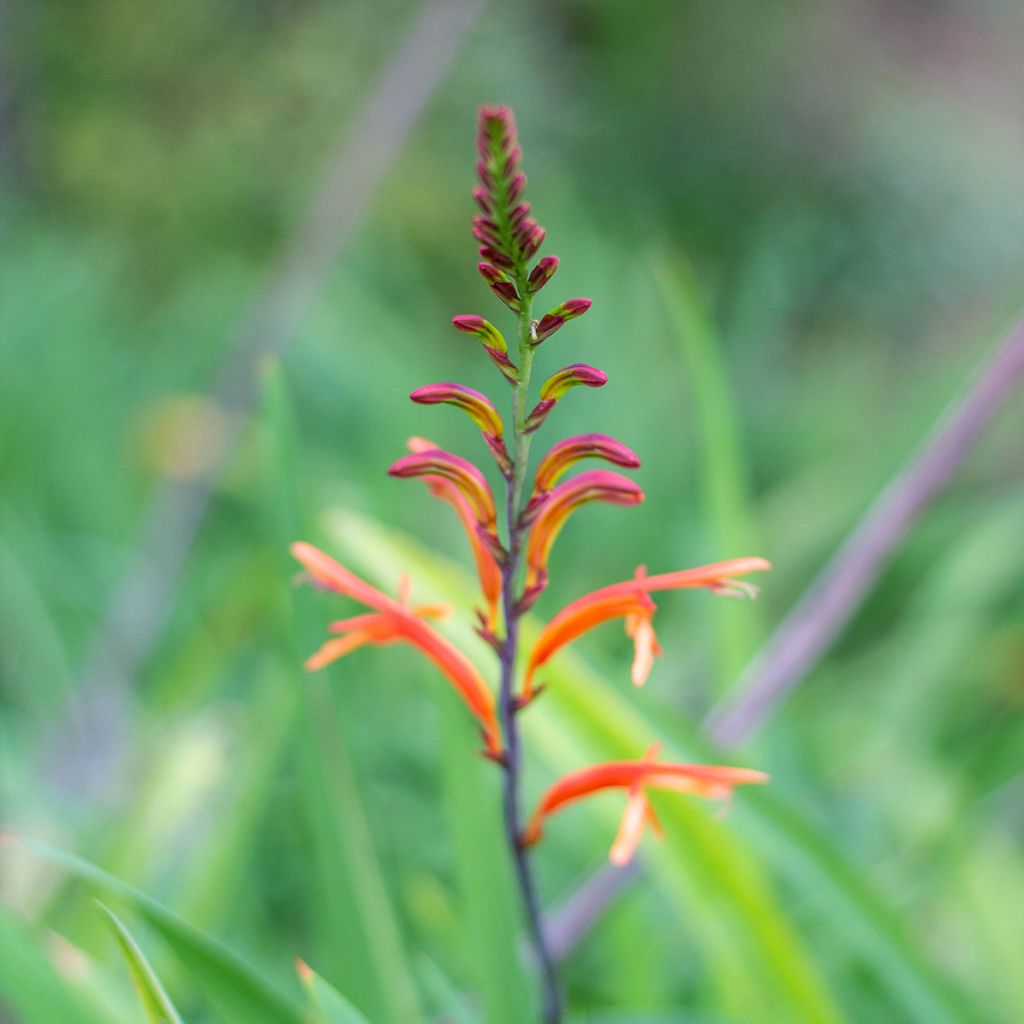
[499,282,563,1024]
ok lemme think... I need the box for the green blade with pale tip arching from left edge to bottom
[11,839,305,1024]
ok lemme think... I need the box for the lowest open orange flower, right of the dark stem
[522,746,768,864]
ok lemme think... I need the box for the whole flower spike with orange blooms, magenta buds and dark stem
[293,106,769,1024]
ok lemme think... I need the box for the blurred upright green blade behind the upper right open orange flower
[651,256,764,692]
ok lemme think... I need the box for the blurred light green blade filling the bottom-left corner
[0,905,110,1024]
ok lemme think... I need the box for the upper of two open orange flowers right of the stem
[522,558,771,700]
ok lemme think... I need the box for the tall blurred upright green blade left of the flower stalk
[264,364,419,1024]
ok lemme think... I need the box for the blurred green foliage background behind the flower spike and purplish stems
[0,0,1024,1024]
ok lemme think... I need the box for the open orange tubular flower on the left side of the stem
[292,542,502,756]
